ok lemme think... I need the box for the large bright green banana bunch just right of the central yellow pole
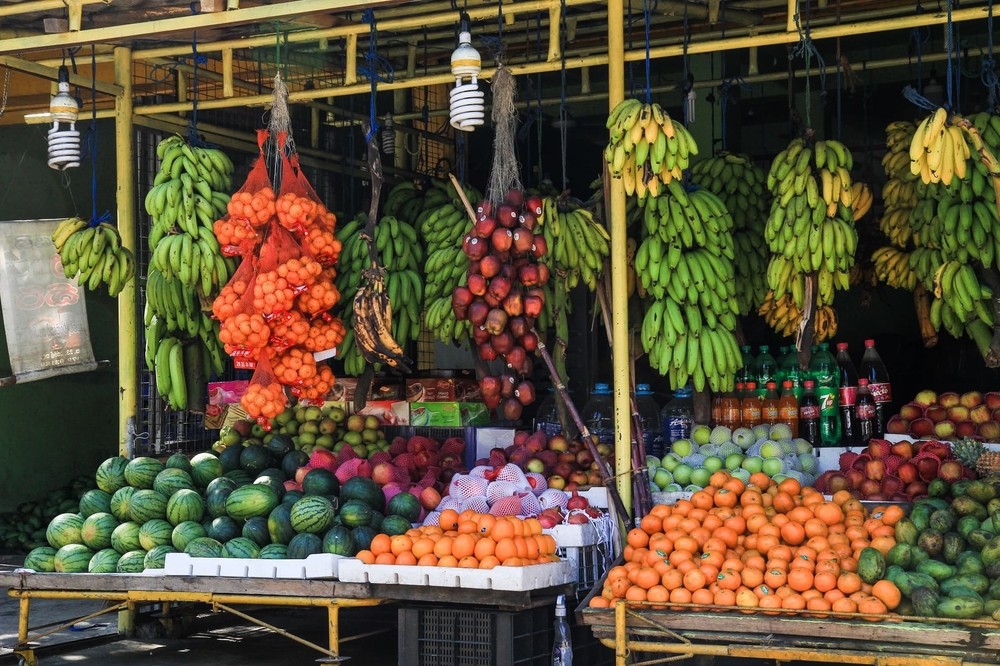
[635,180,742,391]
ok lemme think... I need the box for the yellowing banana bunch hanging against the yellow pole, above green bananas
[604,99,698,198]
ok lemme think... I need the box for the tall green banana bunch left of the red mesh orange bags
[143,135,236,410]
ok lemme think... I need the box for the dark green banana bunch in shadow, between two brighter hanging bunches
[691,151,771,315]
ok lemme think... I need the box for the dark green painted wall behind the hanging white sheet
[0,121,118,511]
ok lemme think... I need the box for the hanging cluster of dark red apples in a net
[451,190,549,421]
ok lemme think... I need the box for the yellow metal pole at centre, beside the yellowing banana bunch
[608,0,632,520]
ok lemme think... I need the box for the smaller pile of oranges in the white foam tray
[357,509,559,569]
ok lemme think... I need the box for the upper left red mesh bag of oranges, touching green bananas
[213,130,284,256]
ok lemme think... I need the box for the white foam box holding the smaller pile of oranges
[339,558,575,592]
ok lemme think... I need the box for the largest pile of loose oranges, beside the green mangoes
[590,471,903,620]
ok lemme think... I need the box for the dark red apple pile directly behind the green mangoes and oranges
[814,439,975,502]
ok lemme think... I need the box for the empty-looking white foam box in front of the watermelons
[163,553,349,579]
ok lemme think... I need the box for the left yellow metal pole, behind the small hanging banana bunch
[115,46,139,455]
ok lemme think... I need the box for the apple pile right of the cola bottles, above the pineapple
[885,390,1000,442]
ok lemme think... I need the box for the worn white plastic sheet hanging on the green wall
[0,220,97,383]
